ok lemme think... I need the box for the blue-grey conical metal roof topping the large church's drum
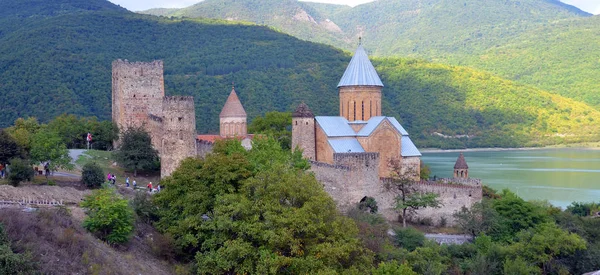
[338,44,383,88]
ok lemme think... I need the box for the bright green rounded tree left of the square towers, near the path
[30,128,73,171]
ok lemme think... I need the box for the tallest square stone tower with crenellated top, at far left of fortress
[112,59,165,146]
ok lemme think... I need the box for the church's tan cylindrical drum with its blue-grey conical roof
[338,43,383,121]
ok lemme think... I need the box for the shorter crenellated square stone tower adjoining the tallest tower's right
[160,96,196,178]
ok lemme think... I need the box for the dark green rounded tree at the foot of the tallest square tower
[114,128,158,177]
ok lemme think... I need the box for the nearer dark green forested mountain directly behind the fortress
[0,0,600,148]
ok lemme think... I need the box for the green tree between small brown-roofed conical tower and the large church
[248,112,292,150]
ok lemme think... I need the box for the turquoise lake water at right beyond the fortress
[423,148,600,207]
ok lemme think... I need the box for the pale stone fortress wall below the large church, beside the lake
[311,153,482,225]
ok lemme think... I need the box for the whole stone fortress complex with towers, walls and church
[112,42,482,224]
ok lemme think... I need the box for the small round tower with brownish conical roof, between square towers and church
[219,87,248,138]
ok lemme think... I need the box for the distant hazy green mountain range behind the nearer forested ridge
[146,0,600,108]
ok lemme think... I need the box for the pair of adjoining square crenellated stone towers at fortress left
[112,59,196,177]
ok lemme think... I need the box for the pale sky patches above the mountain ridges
[109,0,600,14]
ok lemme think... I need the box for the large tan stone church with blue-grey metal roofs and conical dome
[292,41,421,179]
